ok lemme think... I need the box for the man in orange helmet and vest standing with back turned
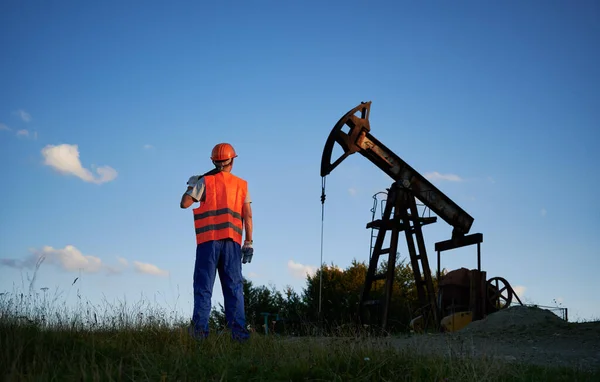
[180,143,254,341]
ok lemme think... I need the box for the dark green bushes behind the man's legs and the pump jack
[210,259,437,335]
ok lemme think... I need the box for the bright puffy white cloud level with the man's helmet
[42,144,117,184]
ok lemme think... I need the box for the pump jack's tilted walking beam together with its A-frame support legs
[321,101,473,330]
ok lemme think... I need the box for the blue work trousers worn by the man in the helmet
[192,239,249,340]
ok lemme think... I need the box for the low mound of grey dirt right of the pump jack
[460,305,568,334]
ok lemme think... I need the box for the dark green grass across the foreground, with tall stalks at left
[0,288,600,381]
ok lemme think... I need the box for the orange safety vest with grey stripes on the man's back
[193,171,248,245]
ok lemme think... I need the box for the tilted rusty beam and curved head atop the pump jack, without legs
[321,101,473,236]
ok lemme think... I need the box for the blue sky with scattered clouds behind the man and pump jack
[0,0,600,319]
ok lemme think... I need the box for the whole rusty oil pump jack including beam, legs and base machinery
[321,101,521,331]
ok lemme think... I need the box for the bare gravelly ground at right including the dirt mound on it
[382,306,600,370]
